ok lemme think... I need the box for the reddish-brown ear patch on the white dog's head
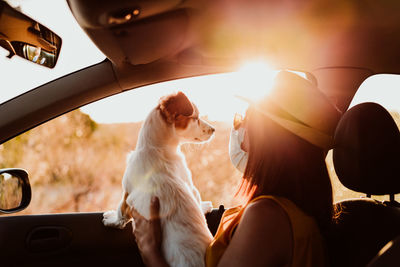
[158,92,195,128]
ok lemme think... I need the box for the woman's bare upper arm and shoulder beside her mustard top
[218,199,293,267]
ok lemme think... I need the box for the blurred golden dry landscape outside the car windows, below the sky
[0,110,400,214]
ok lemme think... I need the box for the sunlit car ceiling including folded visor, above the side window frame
[68,0,400,73]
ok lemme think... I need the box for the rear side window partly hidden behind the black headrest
[327,74,400,201]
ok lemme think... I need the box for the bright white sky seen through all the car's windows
[0,0,400,123]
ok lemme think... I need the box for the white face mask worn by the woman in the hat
[229,128,249,173]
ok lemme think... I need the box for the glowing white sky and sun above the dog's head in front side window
[82,61,277,123]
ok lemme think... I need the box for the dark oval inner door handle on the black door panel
[26,226,72,252]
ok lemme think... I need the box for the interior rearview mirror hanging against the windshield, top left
[0,1,61,68]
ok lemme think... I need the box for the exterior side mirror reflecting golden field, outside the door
[0,169,32,214]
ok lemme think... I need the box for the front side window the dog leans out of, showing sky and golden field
[0,76,247,214]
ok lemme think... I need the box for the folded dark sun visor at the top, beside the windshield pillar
[68,0,189,65]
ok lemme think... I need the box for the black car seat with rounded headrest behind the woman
[328,103,400,267]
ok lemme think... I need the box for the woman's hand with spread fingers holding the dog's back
[131,197,168,267]
